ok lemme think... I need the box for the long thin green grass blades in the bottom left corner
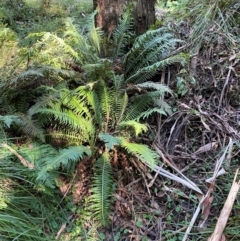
[0,177,71,241]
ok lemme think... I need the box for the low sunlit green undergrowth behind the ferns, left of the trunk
[0,0,93,46]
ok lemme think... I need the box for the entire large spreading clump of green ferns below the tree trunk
[0,7,185,232]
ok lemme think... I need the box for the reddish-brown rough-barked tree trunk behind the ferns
[93,0,156,35]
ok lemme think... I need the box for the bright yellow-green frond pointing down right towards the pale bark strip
[120,138,159,167]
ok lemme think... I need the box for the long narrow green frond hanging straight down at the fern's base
[91,152,113,226]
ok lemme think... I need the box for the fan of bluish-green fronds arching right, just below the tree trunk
[123,28,187,84]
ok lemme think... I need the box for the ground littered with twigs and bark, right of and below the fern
[0,0,240,241]
